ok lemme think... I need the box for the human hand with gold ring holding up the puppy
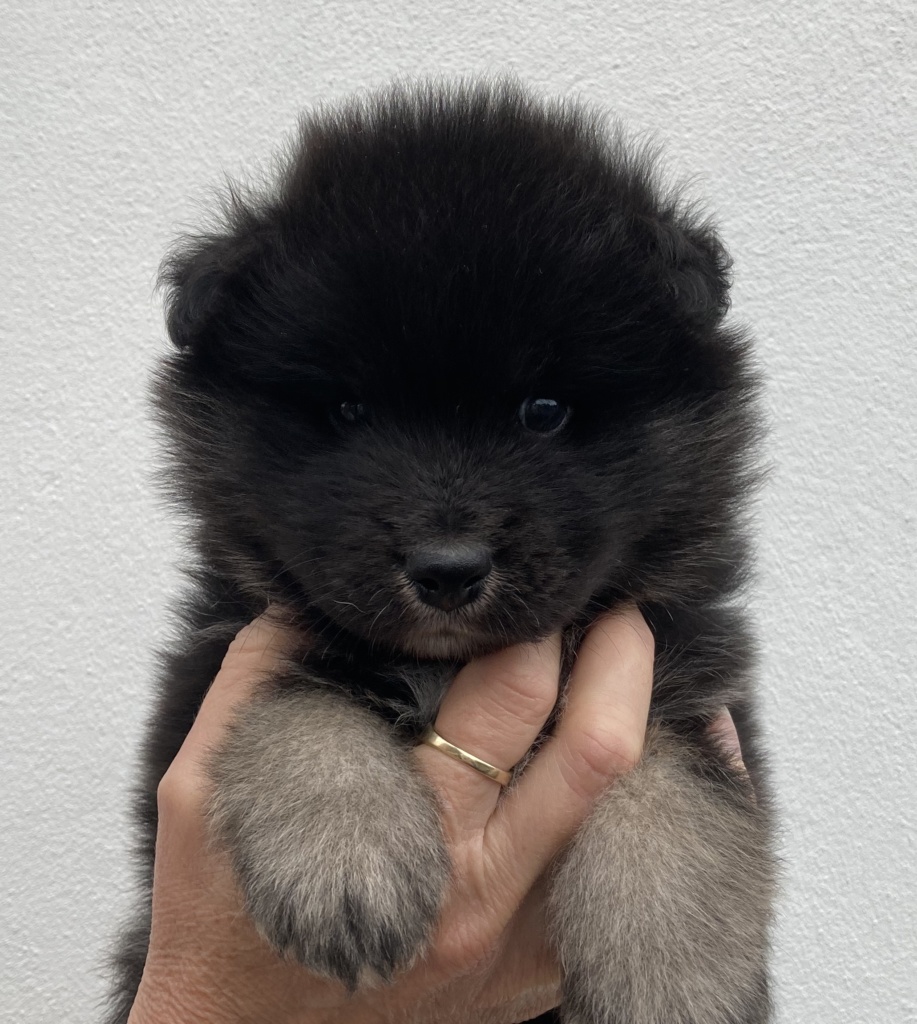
[130,609,724,1024]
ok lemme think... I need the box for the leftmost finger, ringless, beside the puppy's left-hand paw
[161,610,297,783]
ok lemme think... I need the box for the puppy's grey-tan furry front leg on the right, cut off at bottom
[551,730,775,1024]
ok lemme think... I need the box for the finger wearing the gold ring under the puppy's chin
[417,636,561,838]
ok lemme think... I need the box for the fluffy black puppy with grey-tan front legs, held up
[111,84,773,1024]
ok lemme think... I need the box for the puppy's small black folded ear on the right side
[656,214,732,326]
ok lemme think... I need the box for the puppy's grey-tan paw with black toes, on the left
[211,690,448,989]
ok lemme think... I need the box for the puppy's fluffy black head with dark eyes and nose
[157,77,753,657]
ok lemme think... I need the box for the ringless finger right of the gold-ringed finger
[486,606,654,895]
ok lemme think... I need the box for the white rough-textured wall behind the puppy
[0,0,917,1024]
